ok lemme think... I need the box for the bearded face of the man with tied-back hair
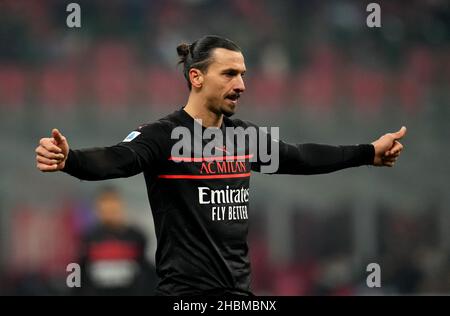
[201,48,246,117]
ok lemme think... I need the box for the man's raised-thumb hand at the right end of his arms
[372,126,406,167]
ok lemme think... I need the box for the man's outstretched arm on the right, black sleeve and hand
[256,127,406,174]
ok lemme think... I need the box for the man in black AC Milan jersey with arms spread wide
[36,36,406,295]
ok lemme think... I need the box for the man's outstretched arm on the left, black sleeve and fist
[36,129,142,181]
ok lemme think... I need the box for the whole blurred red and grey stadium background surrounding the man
[0,0,450,295]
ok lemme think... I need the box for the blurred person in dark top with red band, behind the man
[75,186,156,295]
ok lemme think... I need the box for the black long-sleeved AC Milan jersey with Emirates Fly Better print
[64,109,374,295]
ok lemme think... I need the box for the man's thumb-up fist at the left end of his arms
[36,128,69,172]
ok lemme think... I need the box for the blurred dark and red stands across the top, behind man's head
[0,0,450,112]
